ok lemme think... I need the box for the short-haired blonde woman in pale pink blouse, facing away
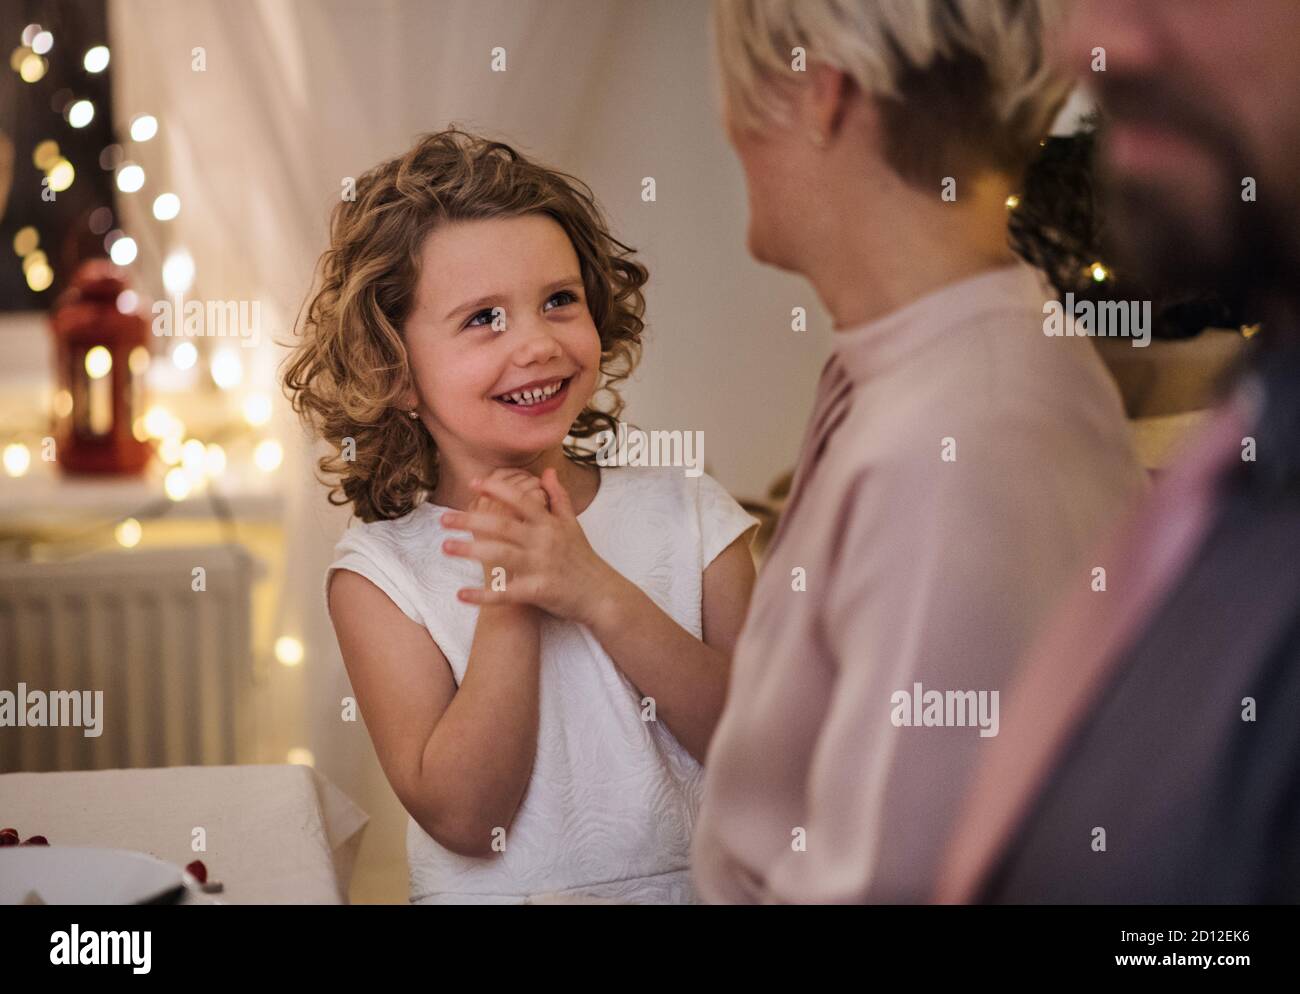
[693,0,1144,902]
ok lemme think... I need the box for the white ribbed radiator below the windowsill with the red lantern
[0,544,260,772]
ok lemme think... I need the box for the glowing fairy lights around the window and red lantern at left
[0,23,283,548]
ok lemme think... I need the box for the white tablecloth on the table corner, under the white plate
[0,765,369,904]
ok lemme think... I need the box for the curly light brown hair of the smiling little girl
[283,126,649,521]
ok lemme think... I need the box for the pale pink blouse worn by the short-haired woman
[692,264,1145,902]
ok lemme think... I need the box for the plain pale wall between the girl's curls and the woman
[575,0,831,496]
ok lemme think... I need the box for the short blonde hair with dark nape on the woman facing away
[712,0,1070,187]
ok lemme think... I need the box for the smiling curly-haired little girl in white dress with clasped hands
[285,129,757,903]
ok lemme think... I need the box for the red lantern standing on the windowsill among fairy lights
[49,259,151,474]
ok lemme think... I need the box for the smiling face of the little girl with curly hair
[403,214,601,466]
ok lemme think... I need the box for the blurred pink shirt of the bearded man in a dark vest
[935,392,1261,904]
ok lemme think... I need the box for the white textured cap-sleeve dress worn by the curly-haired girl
[319,466,757,904]
